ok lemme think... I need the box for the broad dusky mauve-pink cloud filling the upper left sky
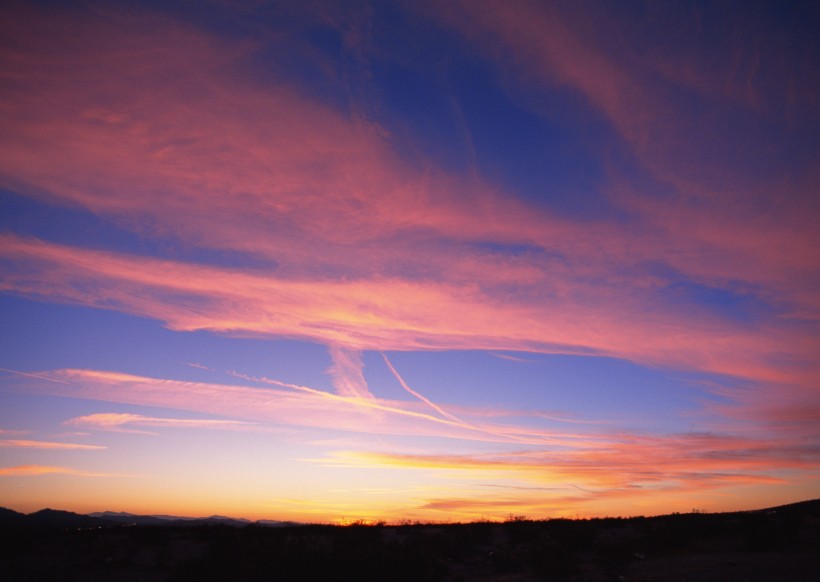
[0,1,572,271]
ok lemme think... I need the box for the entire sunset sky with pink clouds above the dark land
[0,0,820,523]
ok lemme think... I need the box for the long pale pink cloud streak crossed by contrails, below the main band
[4,370,616,446]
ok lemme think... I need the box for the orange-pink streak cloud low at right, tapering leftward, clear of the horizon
[316,434,820,492]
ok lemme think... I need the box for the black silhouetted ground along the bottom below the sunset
[0,500,820,582]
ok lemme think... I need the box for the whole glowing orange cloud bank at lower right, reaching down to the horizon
[310,434,820,520]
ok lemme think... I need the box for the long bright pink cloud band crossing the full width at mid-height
[0,235,817,392]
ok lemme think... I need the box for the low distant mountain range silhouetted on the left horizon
[0,507,300,528]
